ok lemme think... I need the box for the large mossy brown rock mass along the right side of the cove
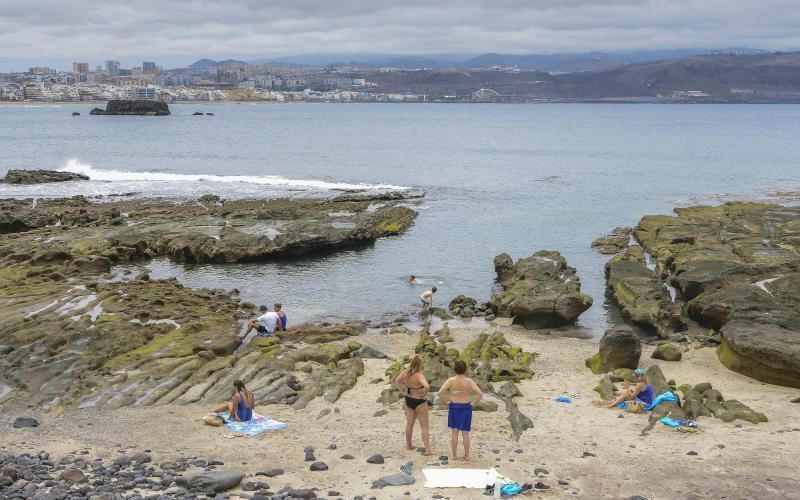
[606,203,800,387]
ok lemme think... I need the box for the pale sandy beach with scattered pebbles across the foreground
[0,321,800,499]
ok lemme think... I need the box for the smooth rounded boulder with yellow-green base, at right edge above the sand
[717,321,800,388]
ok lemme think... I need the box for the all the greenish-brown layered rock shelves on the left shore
[0,193,415,408]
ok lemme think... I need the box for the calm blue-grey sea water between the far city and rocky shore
[0,104,800,336]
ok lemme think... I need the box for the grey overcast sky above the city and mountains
[0,0,800,71]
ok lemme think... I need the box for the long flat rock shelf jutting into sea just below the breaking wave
[0,193,417,264]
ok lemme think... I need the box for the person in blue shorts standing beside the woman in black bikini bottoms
[439,359,483,460]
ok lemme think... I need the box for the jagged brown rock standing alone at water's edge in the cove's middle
[489,250,592,329]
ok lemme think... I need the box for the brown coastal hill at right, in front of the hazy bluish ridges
[369,52,800,102]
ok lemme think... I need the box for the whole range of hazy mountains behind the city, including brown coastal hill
[181,49,800,102]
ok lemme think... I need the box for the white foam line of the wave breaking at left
[59,160,410,191]
